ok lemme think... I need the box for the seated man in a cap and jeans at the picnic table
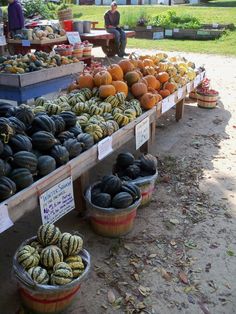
[104,2,129,58]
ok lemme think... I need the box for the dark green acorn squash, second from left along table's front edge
[9,168,34,191]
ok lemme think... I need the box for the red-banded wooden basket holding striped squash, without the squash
[13,237,90,314]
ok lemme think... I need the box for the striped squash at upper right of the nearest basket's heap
[58,232,83,256]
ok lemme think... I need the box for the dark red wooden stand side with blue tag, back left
[7,36,68,55]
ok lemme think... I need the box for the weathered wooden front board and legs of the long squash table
[0,73,204,226]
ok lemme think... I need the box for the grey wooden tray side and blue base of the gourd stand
[0,62,84,103]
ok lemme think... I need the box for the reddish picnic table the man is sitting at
[80,29,135,57]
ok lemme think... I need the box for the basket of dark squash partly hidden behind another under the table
[129,172,158,207]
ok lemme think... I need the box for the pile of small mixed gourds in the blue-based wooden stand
[0,51,80,74]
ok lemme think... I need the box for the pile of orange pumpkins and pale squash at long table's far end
[69,53,197,110]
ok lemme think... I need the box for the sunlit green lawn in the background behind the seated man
[73,0,236,56]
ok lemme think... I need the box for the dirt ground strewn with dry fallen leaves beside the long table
[0,51,236,314]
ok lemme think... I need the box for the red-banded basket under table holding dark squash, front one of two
[85,183,141,238]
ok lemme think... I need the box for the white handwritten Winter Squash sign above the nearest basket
[39,177,75,224]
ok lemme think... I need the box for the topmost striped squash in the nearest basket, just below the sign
[37,224,61,246]
